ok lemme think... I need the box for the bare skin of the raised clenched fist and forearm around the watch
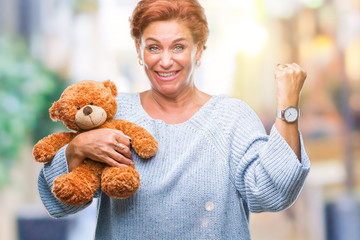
[275,63,307,160]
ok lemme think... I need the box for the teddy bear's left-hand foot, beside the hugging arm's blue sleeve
[52,171,100,206]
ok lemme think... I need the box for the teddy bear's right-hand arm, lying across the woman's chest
[106,119,158,158]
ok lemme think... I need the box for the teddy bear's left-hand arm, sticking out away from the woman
[33,132,76,163]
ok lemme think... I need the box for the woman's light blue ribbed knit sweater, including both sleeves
[39,94,310,240]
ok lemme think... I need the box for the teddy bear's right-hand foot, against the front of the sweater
[101,167,140,199]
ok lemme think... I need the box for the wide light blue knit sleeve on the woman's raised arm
[230,100,310,212]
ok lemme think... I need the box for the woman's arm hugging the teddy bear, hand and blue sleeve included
[38,129,133,218]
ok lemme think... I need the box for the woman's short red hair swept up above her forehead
[130,0,209,49]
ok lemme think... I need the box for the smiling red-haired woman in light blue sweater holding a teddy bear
[39,0,310,239]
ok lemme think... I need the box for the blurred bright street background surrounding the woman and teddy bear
[0,0,360,240]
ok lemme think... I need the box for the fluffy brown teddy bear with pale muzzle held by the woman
[33,80,158,206]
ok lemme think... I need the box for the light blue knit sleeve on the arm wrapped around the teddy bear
[38,145,91,218]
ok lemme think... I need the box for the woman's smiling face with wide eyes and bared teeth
[136,20,202,97]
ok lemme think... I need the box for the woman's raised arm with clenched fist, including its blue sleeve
[228,64,310,212]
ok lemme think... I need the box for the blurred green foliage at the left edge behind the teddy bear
[0,38,65,188]
